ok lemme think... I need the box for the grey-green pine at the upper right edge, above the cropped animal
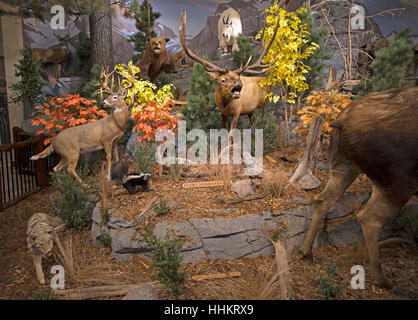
[366,29,415,92]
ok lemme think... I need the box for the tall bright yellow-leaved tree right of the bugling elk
[256,0,319,141]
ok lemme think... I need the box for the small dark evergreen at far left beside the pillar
[10,47,45,119]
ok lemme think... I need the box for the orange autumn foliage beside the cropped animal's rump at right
[293,90,351,137]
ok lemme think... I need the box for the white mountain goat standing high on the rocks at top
[218,8,242,53]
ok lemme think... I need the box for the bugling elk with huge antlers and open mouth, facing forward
[179,12,279,137]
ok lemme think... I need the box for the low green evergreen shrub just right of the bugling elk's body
[251,110,280,154]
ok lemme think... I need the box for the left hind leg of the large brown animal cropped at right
[300,163,359,259]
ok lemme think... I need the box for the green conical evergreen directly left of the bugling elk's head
[181,63,222,130]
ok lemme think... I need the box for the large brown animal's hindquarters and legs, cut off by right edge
[300,87,418,287]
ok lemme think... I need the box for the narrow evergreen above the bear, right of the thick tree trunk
[129,0,161,64]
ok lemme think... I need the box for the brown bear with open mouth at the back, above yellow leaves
[138,38,177,82]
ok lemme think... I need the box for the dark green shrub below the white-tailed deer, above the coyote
[51,171,91,231]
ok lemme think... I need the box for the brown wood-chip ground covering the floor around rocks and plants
[0,150,418,300]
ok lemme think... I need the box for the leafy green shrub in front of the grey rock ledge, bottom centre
[139,225,186,299]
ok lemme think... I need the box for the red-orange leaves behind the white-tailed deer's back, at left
[32,95,107,145]
